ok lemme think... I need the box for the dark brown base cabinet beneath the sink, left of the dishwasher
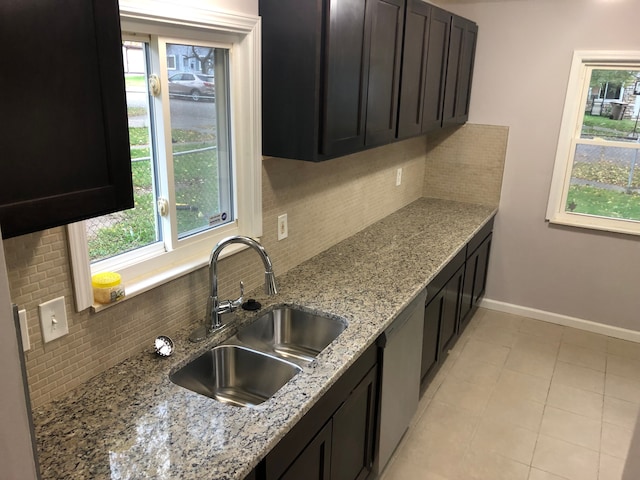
[257,345,378,480]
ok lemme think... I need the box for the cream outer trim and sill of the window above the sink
[67,0,262,311]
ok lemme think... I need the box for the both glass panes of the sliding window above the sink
[85,41,236,262]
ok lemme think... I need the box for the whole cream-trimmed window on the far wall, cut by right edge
[546,51,640,235]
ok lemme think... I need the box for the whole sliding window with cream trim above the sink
[68,0,262,311]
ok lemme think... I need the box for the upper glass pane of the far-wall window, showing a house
[580,69,640,142]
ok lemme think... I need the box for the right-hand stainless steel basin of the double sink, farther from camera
[236,307,347,363]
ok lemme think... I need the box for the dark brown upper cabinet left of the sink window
[0,0,133,238]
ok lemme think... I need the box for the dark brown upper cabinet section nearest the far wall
[398,0,478,139]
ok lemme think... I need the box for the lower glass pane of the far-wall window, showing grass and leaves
[565,144,640,220]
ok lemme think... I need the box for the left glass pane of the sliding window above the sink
[85,41,160,262]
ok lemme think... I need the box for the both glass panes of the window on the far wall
[564,67,640,225]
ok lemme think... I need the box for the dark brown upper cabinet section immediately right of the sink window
[260,0,405,161]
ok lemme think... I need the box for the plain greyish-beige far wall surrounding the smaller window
[438,0,640,330]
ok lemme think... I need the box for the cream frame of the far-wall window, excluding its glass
[546,50,640,235]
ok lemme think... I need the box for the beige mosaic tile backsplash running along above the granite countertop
[4,125,508,407]
